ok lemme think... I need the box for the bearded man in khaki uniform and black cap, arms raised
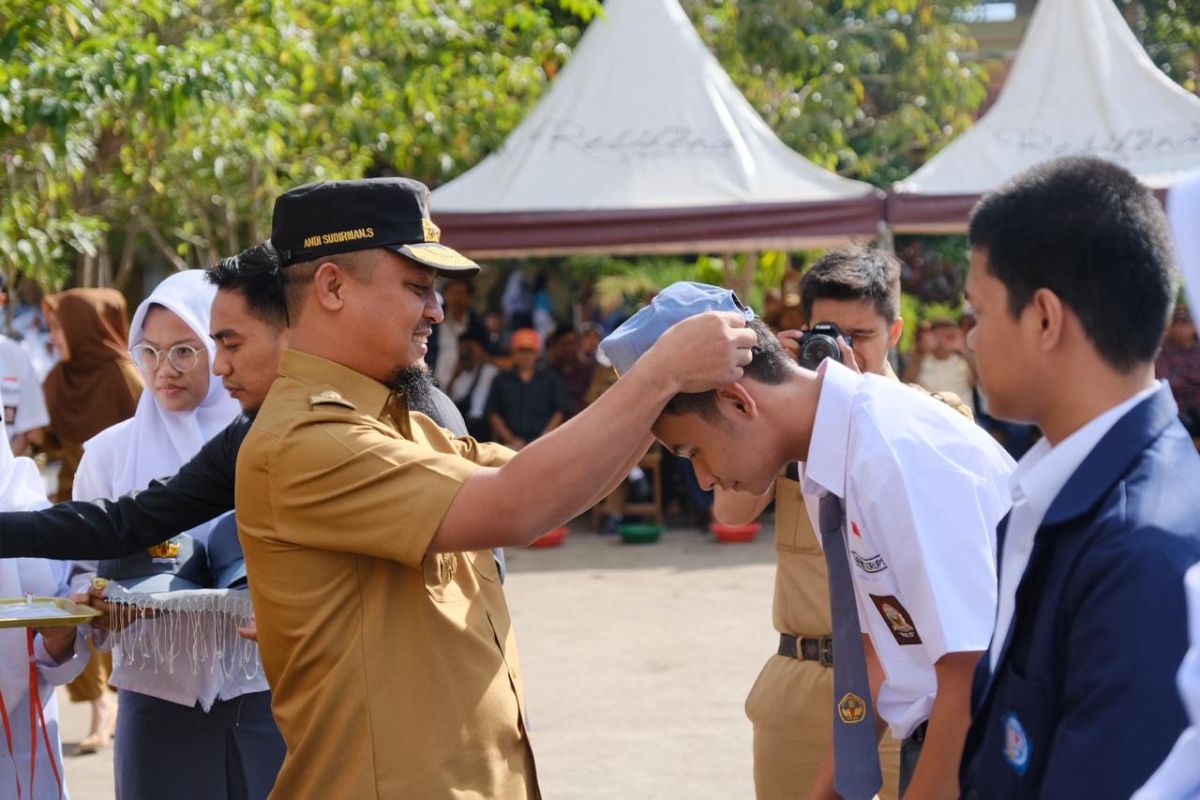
[236,179,754,800]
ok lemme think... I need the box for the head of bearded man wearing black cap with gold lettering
[271,178,479,391]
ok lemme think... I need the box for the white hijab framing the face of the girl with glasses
[113,270,241,497]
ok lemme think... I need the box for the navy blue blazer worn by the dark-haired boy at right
[959,387,1200,800]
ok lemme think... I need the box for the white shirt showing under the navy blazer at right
[988,383,1170,670]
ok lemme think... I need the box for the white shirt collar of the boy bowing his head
[804,359,863,498]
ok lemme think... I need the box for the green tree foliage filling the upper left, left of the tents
[0,0,599,285]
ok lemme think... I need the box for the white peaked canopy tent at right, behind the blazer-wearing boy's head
[888,0,1200,233]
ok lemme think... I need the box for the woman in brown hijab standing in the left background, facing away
[42,289,142,753]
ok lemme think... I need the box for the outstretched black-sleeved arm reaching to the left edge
[0,416,252,559]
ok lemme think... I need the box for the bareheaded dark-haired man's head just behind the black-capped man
[208,241,288,410]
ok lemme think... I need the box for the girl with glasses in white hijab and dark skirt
[74,270,284,800]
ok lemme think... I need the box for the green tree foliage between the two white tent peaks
[686,0,988,186]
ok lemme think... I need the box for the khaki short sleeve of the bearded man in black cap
[269,417,479,567]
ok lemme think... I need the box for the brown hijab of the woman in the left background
[42,289,142,443]
